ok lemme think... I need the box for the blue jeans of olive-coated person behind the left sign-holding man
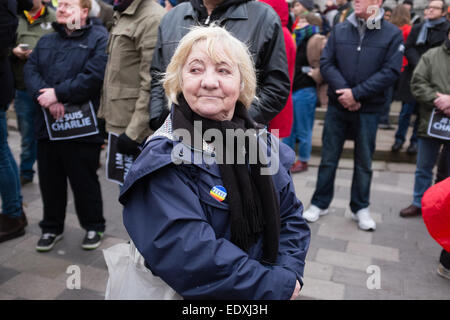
[14,90,37,180]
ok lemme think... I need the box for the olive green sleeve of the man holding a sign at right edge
[411,53,437,110]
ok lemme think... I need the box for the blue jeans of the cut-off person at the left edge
[0,110,22,217]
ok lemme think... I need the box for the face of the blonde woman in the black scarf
[181,41,241,121]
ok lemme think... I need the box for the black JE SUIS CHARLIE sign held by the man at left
[42,101,98,140]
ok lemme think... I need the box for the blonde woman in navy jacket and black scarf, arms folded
[120,26,310,299]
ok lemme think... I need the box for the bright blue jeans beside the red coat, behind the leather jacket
[283,87,317,162]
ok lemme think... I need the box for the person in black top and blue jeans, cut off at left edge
[0,0,33,242]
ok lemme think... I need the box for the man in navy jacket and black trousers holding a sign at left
[24,0,108,251]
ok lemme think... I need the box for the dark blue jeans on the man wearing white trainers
[311,106,379,213]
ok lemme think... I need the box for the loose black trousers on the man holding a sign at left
[37,140,105,234]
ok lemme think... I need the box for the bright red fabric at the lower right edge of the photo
[422,178,450,252]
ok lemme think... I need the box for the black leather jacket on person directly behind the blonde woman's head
[149,0,290,130]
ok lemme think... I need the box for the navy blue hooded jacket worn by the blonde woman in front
[119,120,310,299]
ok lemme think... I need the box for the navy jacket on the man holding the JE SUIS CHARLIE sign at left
[24,22,108,143]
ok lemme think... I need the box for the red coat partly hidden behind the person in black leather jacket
[261,0,296,138]
